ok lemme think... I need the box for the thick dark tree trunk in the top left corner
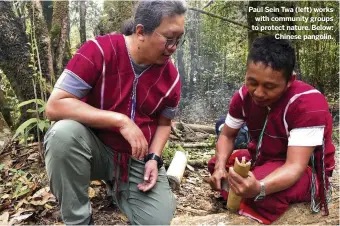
[0,1,40,122]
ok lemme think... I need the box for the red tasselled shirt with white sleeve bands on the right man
[226,81,335,215]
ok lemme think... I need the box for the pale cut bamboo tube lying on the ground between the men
[166,151,188,190]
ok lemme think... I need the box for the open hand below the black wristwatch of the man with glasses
[138,160,158,192]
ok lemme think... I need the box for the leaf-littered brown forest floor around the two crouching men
[0,122,340,225]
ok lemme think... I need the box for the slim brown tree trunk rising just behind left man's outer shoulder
[51,1,69,76]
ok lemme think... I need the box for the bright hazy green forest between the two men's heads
[175,1,248,123]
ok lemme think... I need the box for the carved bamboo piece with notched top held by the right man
[227,156,250,212]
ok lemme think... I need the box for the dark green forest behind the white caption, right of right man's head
[246,1,339,96]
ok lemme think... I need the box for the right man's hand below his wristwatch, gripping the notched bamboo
[228,167,261,198]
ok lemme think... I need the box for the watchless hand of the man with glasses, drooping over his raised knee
[119,117,148,160]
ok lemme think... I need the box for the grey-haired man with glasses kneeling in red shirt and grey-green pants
[44,0,186,225]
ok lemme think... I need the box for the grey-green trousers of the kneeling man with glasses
[44,120,176,225]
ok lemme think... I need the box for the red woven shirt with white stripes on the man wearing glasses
[55,34,181,181]
